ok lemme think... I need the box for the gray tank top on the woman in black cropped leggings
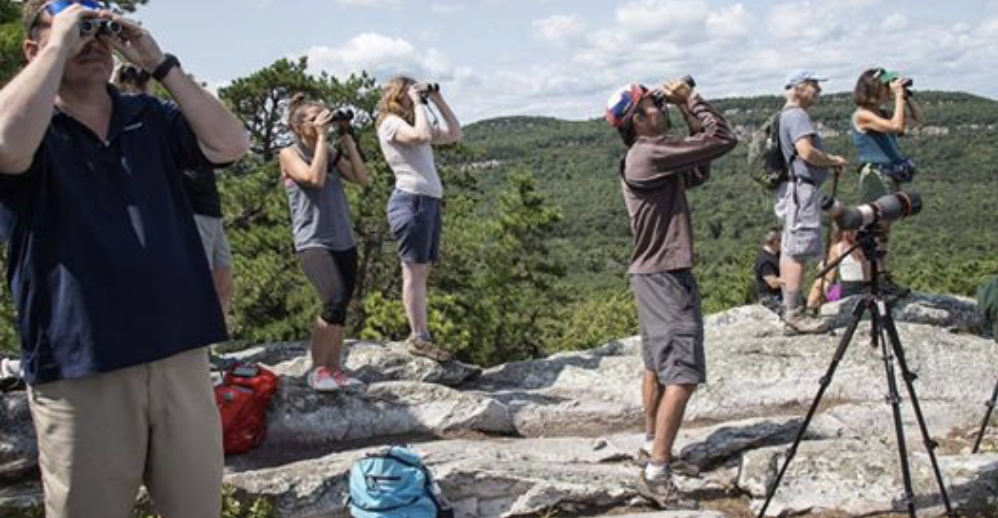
[284,143,356,252]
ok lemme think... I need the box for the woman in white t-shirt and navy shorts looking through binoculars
[377,77,462,361]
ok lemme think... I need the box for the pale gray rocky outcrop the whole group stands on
[0,295,998,517]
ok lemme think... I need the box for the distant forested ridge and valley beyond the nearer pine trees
[467,92,998,350]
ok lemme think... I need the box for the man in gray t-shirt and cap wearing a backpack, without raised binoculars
[775,70,848,334]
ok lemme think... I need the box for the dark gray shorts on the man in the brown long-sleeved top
[631,270,707,385]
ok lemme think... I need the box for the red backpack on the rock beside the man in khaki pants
[215,364,277,454]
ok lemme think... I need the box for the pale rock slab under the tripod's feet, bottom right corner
[738,439,998,516]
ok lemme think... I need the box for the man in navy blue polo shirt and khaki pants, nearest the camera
[0,0,249,518]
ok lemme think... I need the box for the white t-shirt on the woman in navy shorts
[378,112,444,198]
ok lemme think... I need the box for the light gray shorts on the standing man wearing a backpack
[776,181,822,260]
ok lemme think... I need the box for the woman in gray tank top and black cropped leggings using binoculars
[280,93,367,391]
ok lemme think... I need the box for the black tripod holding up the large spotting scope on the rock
[759,228,955,518]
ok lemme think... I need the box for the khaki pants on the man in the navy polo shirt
[29,349,223,518]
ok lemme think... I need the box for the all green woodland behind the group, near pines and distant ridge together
[0,30,998,364]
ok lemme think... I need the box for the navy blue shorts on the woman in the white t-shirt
[388,189,443,264]
